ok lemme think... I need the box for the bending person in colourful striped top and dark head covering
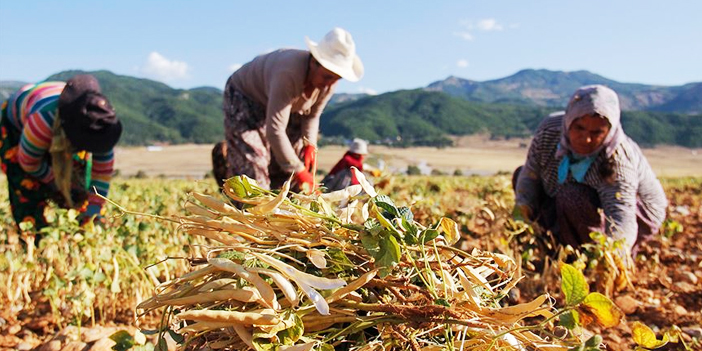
[0,74,122,229]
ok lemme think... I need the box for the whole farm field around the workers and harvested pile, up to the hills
[0,141,702,350]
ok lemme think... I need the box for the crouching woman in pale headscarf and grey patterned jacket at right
[514,85,667,253]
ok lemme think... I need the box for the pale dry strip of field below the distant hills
[115,137,702,179]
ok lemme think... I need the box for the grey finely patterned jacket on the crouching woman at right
[516,114,668,248]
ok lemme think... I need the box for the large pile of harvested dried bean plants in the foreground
[138,170,565,350]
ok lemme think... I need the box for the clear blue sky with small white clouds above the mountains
[0,0,702,93]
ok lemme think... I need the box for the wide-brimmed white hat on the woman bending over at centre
[305,27,363,82]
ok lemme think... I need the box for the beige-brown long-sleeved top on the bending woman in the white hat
[227,49,335,172]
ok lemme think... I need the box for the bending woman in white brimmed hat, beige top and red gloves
[212,28,363,189]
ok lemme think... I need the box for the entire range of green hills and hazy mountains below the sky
[0,70,702,147]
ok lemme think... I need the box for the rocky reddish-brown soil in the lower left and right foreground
[0,185,702,350]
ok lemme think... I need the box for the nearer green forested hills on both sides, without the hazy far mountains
[11,71,702,147]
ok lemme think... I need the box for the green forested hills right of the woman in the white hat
[321,89,702,147]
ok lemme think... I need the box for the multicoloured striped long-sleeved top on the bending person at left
[7,82,114,210]
